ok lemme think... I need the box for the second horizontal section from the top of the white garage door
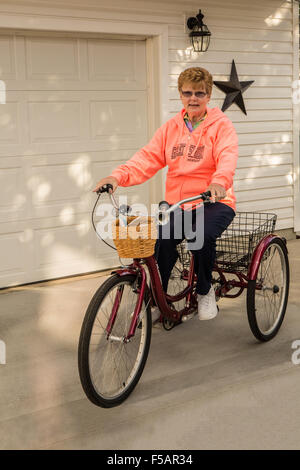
[0,91,147,149]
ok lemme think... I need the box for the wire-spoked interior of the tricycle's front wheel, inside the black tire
[80,275,151,406]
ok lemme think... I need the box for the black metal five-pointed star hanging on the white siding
[214,60,254,115]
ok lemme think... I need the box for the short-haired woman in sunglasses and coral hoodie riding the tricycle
[94,67,238,320]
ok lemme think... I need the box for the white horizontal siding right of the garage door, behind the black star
[169,1,294,229]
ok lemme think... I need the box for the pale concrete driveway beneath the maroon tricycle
[0,240,300,450]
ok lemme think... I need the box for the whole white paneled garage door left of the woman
[0,32,149,287]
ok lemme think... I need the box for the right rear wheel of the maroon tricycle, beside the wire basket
[247,238,290,342]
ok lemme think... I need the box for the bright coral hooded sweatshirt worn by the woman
[111,108,238,210]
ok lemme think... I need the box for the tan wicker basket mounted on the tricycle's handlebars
[112,216,157,258]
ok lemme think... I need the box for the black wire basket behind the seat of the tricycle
[177,212,277,272]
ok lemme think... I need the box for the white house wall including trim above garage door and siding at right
[0,0,300,230]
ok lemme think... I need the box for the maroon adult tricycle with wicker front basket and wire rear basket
[78,185,289,408]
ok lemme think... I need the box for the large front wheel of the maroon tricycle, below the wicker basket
[78,274,152,408]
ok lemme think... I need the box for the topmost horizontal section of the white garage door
[0,33,147,91]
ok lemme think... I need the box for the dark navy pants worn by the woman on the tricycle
[155,202,235,295]
